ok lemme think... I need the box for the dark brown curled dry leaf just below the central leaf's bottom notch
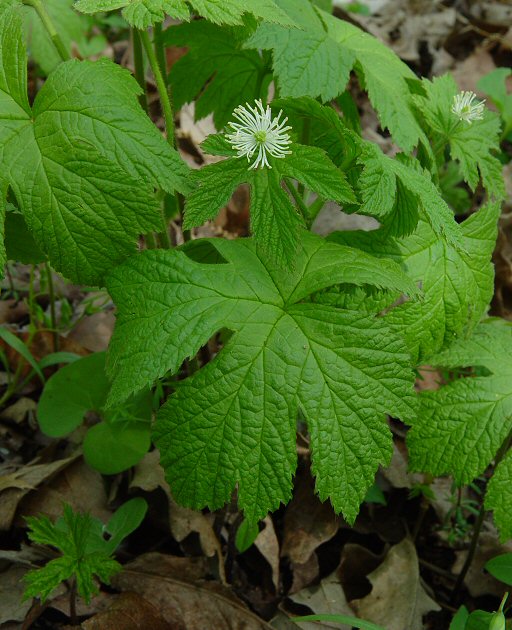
[281,470,339,564]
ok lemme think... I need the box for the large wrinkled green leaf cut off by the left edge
[0,0,187,284]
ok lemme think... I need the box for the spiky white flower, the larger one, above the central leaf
[226,100,291,168]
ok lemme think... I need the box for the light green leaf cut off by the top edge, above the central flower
[75,0,293,28]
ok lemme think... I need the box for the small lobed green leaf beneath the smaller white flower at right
[416,75,505,200]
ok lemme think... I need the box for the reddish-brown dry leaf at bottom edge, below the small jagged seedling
[81,593,173,630]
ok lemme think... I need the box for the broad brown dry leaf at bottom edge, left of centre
[112,553,270,630]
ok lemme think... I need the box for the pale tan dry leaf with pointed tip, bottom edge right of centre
[351,538,440,630]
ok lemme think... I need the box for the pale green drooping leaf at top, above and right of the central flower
[246,0,426,151]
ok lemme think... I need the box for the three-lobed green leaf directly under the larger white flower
[184,144,355,266]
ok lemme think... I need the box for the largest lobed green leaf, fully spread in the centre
[108,233,414,521]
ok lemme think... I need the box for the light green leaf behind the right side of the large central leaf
[330,204,500,365]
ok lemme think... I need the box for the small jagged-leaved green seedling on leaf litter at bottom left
[24,498,147,616]
